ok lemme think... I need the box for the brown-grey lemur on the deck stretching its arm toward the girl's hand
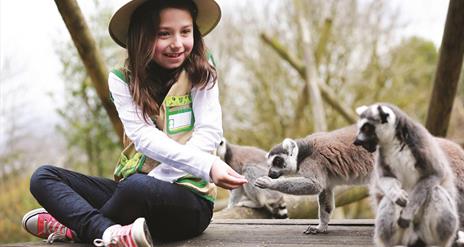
[255,125,464,234]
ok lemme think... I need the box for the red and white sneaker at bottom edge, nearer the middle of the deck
[93,218,153,247]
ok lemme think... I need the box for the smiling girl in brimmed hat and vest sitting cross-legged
[23,0,246,246]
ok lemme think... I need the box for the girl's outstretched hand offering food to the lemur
[209,159,248,190]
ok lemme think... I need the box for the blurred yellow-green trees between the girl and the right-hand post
[212,0,437,145]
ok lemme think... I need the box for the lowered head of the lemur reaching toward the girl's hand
[267,138,298,178]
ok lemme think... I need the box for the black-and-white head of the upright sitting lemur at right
[354,104,395,153]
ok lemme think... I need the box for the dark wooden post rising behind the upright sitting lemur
[426,0,464,136]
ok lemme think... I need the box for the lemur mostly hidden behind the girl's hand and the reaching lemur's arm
[217,139,288,219]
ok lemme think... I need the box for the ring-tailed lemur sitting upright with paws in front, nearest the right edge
[355,104,459,246]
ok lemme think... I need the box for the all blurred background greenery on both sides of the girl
[0,0,464,243]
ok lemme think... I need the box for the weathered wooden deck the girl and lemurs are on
[1,219,374,247]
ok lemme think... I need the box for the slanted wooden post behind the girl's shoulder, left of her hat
[55,0,123,143]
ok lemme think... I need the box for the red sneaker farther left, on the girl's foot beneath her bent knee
[22,208,76,244]
